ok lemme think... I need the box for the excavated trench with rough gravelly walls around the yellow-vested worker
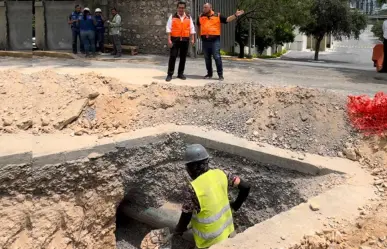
[0,133,344,249]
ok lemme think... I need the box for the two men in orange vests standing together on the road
[165,1,244,82]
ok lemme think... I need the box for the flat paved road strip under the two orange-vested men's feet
[0,46,387,95]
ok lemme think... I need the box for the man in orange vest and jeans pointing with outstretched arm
[197,3,244,81]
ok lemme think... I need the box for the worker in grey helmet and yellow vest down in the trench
[175,144,250,248]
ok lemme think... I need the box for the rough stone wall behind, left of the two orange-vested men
[109,0,191,54]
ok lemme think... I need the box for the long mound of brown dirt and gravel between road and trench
[0,71,353,156]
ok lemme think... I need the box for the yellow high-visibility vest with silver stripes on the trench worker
[191,169,234,248]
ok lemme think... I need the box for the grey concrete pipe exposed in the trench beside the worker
[121,203,194,241]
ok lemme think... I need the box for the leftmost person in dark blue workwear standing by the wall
[79,8,96,57]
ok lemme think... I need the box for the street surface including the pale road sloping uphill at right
[0,26,387,95]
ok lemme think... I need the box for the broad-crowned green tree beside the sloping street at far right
[300,0,367,60]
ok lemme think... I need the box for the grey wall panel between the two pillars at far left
[7,1,32,51]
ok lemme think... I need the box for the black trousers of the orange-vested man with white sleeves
[168,40,189,76]
